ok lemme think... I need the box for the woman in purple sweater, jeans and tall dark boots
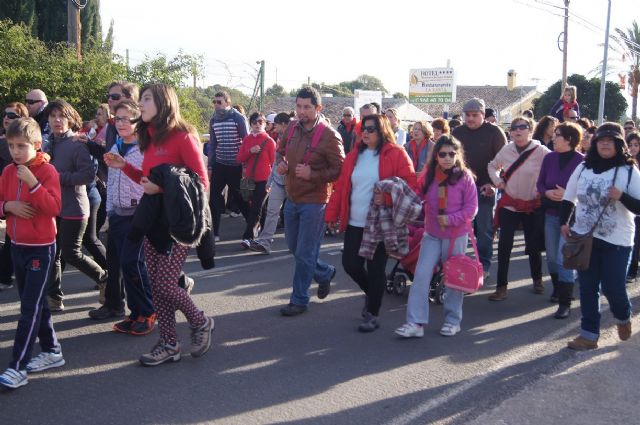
[537,122,584,319]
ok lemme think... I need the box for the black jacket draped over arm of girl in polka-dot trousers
[129,164,215,269]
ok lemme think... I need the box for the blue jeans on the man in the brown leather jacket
[284,199,335,305]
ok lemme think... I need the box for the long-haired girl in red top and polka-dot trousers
[105,84,214,366]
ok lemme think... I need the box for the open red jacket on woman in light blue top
[325,143,418,232]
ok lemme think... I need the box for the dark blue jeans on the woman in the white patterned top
[578,238,632,341]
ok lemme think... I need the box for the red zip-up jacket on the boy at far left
[0,152,62,246]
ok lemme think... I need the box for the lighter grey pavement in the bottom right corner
[471,314,640,425]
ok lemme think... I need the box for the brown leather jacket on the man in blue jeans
[278,117,344,204]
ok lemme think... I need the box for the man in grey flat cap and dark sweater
[453,97,507,281]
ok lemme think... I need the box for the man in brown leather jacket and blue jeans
[278,86,344,316]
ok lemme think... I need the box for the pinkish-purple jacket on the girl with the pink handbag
[422,173,478,239]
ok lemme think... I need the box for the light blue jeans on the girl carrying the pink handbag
[407,233,468,326]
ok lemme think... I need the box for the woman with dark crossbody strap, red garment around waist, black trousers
[487,117,549,301]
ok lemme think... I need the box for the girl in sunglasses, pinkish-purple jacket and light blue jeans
[396,136,478,338]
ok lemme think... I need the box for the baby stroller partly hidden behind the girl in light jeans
[386,226,444,304]
